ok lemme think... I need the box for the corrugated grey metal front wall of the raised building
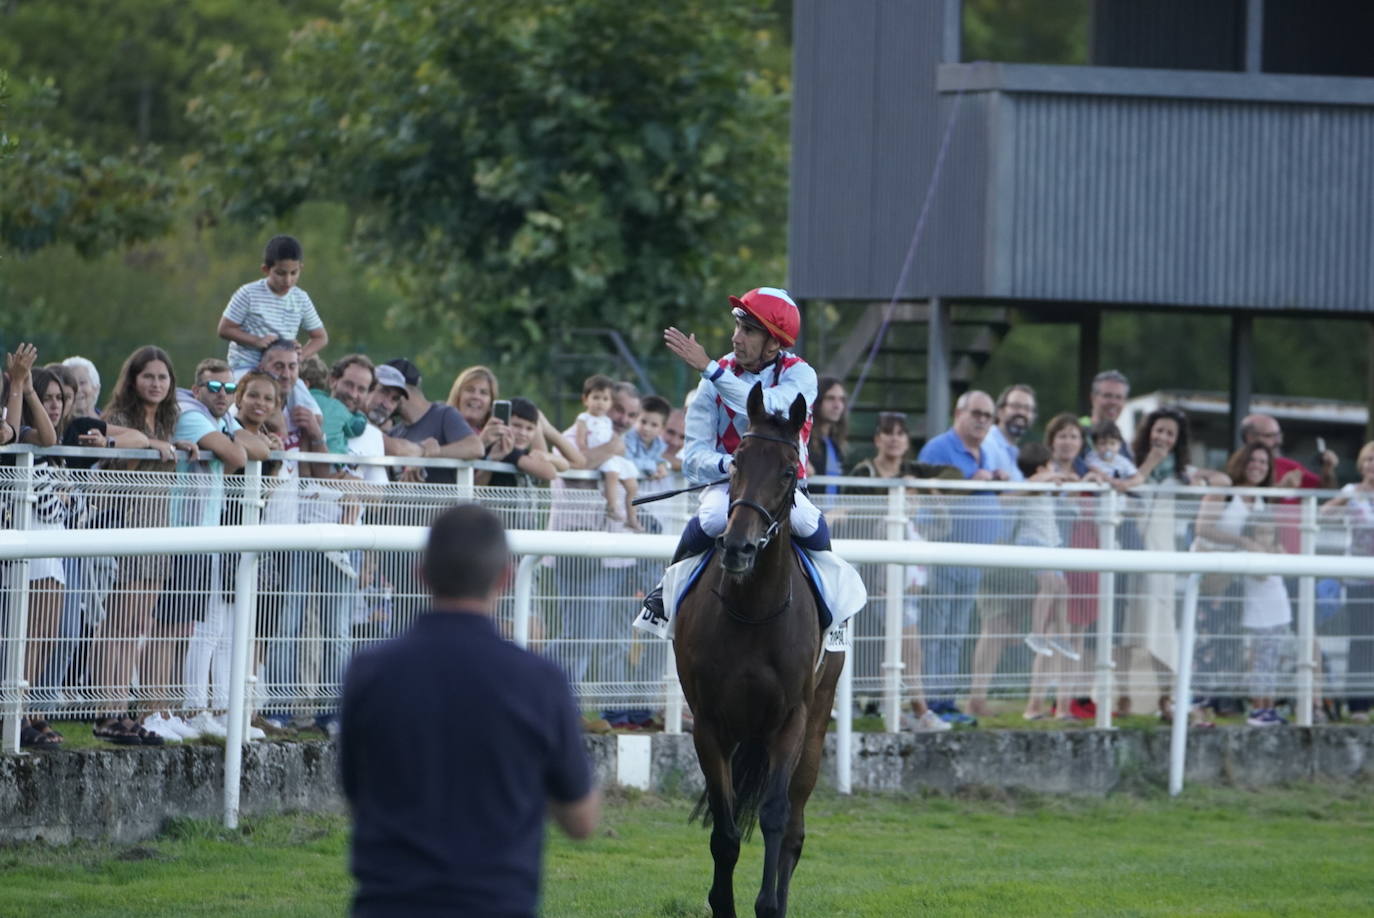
[989,93,1374,312]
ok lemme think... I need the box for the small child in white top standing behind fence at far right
[1241,510,1293,727]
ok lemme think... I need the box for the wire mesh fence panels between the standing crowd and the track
[0,445,1374,717]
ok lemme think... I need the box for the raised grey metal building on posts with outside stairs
[789,0,1374,442]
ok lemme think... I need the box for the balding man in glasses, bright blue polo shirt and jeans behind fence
[918,390,1009,724]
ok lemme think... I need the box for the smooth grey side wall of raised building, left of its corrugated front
[789,0,987,300]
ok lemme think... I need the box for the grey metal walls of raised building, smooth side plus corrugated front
[789,0,1374,312]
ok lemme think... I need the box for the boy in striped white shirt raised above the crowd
[216,236,330,379]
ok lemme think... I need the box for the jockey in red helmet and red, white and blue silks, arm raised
[644,287,830,617]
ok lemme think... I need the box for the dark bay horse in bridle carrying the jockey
[673,385,844,918]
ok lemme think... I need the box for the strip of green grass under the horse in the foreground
[0,782,1374,918]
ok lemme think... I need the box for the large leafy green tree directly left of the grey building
[192,0,787,384]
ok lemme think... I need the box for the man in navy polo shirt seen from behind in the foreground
[339,504,600,918]
